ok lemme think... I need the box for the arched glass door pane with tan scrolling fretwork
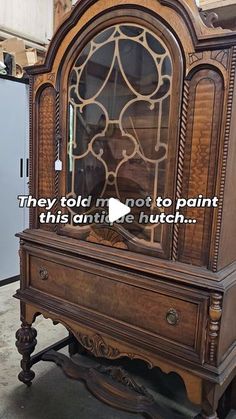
[67,24,172,249]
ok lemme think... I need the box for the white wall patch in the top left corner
[0,0,53,43]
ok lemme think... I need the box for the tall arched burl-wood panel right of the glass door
[180,70,223,265]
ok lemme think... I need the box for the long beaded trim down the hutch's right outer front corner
[212,46,236,272]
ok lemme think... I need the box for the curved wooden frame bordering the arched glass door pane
[57,6,184,258]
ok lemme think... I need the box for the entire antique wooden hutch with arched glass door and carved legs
[16,0,236,418]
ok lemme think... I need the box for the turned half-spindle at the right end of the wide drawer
[208,293,223,364]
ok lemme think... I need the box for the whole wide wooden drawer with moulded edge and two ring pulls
[28,248,207,357]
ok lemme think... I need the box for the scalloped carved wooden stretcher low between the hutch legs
[42,350,167,419]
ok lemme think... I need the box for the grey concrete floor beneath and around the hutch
[0,283,236,419]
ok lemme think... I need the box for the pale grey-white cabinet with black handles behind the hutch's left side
[0,78,29,281]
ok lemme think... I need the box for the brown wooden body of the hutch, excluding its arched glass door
[16,0,236,419]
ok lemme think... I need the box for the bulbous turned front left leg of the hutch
[16,322,37,386]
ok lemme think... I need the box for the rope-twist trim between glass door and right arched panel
[172,80,189,261]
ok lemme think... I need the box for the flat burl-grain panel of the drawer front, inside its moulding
[30,256,198,347]
